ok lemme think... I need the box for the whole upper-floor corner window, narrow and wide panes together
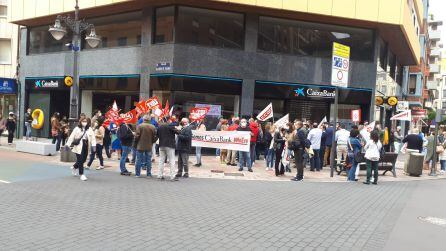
[153,6,245,49]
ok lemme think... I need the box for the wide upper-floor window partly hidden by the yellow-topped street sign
[258,17,373,61]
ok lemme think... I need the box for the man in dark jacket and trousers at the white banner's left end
[175,118,192,178]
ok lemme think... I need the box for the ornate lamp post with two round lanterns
[48,0,101,128]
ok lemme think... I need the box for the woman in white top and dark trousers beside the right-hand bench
[364,131,382,185]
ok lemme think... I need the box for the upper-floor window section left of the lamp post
[28,25,72,54]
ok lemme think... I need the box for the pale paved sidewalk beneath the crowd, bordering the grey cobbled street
[0,140,446,182]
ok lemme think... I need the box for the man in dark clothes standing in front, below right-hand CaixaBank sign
[291,121,307,181]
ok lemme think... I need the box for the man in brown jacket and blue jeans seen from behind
[135,115,157,178]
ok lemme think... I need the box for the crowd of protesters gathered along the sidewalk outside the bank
[6,106,446,184]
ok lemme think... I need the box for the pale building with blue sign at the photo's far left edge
[0,0,18,117]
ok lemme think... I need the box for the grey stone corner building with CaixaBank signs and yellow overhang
[9,0,424,137]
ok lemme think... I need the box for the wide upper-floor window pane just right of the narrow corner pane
[175,6,245,49]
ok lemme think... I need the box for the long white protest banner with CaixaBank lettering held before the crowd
[192,130,251,152]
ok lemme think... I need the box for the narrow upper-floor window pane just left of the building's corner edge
[153,6,175,43]
